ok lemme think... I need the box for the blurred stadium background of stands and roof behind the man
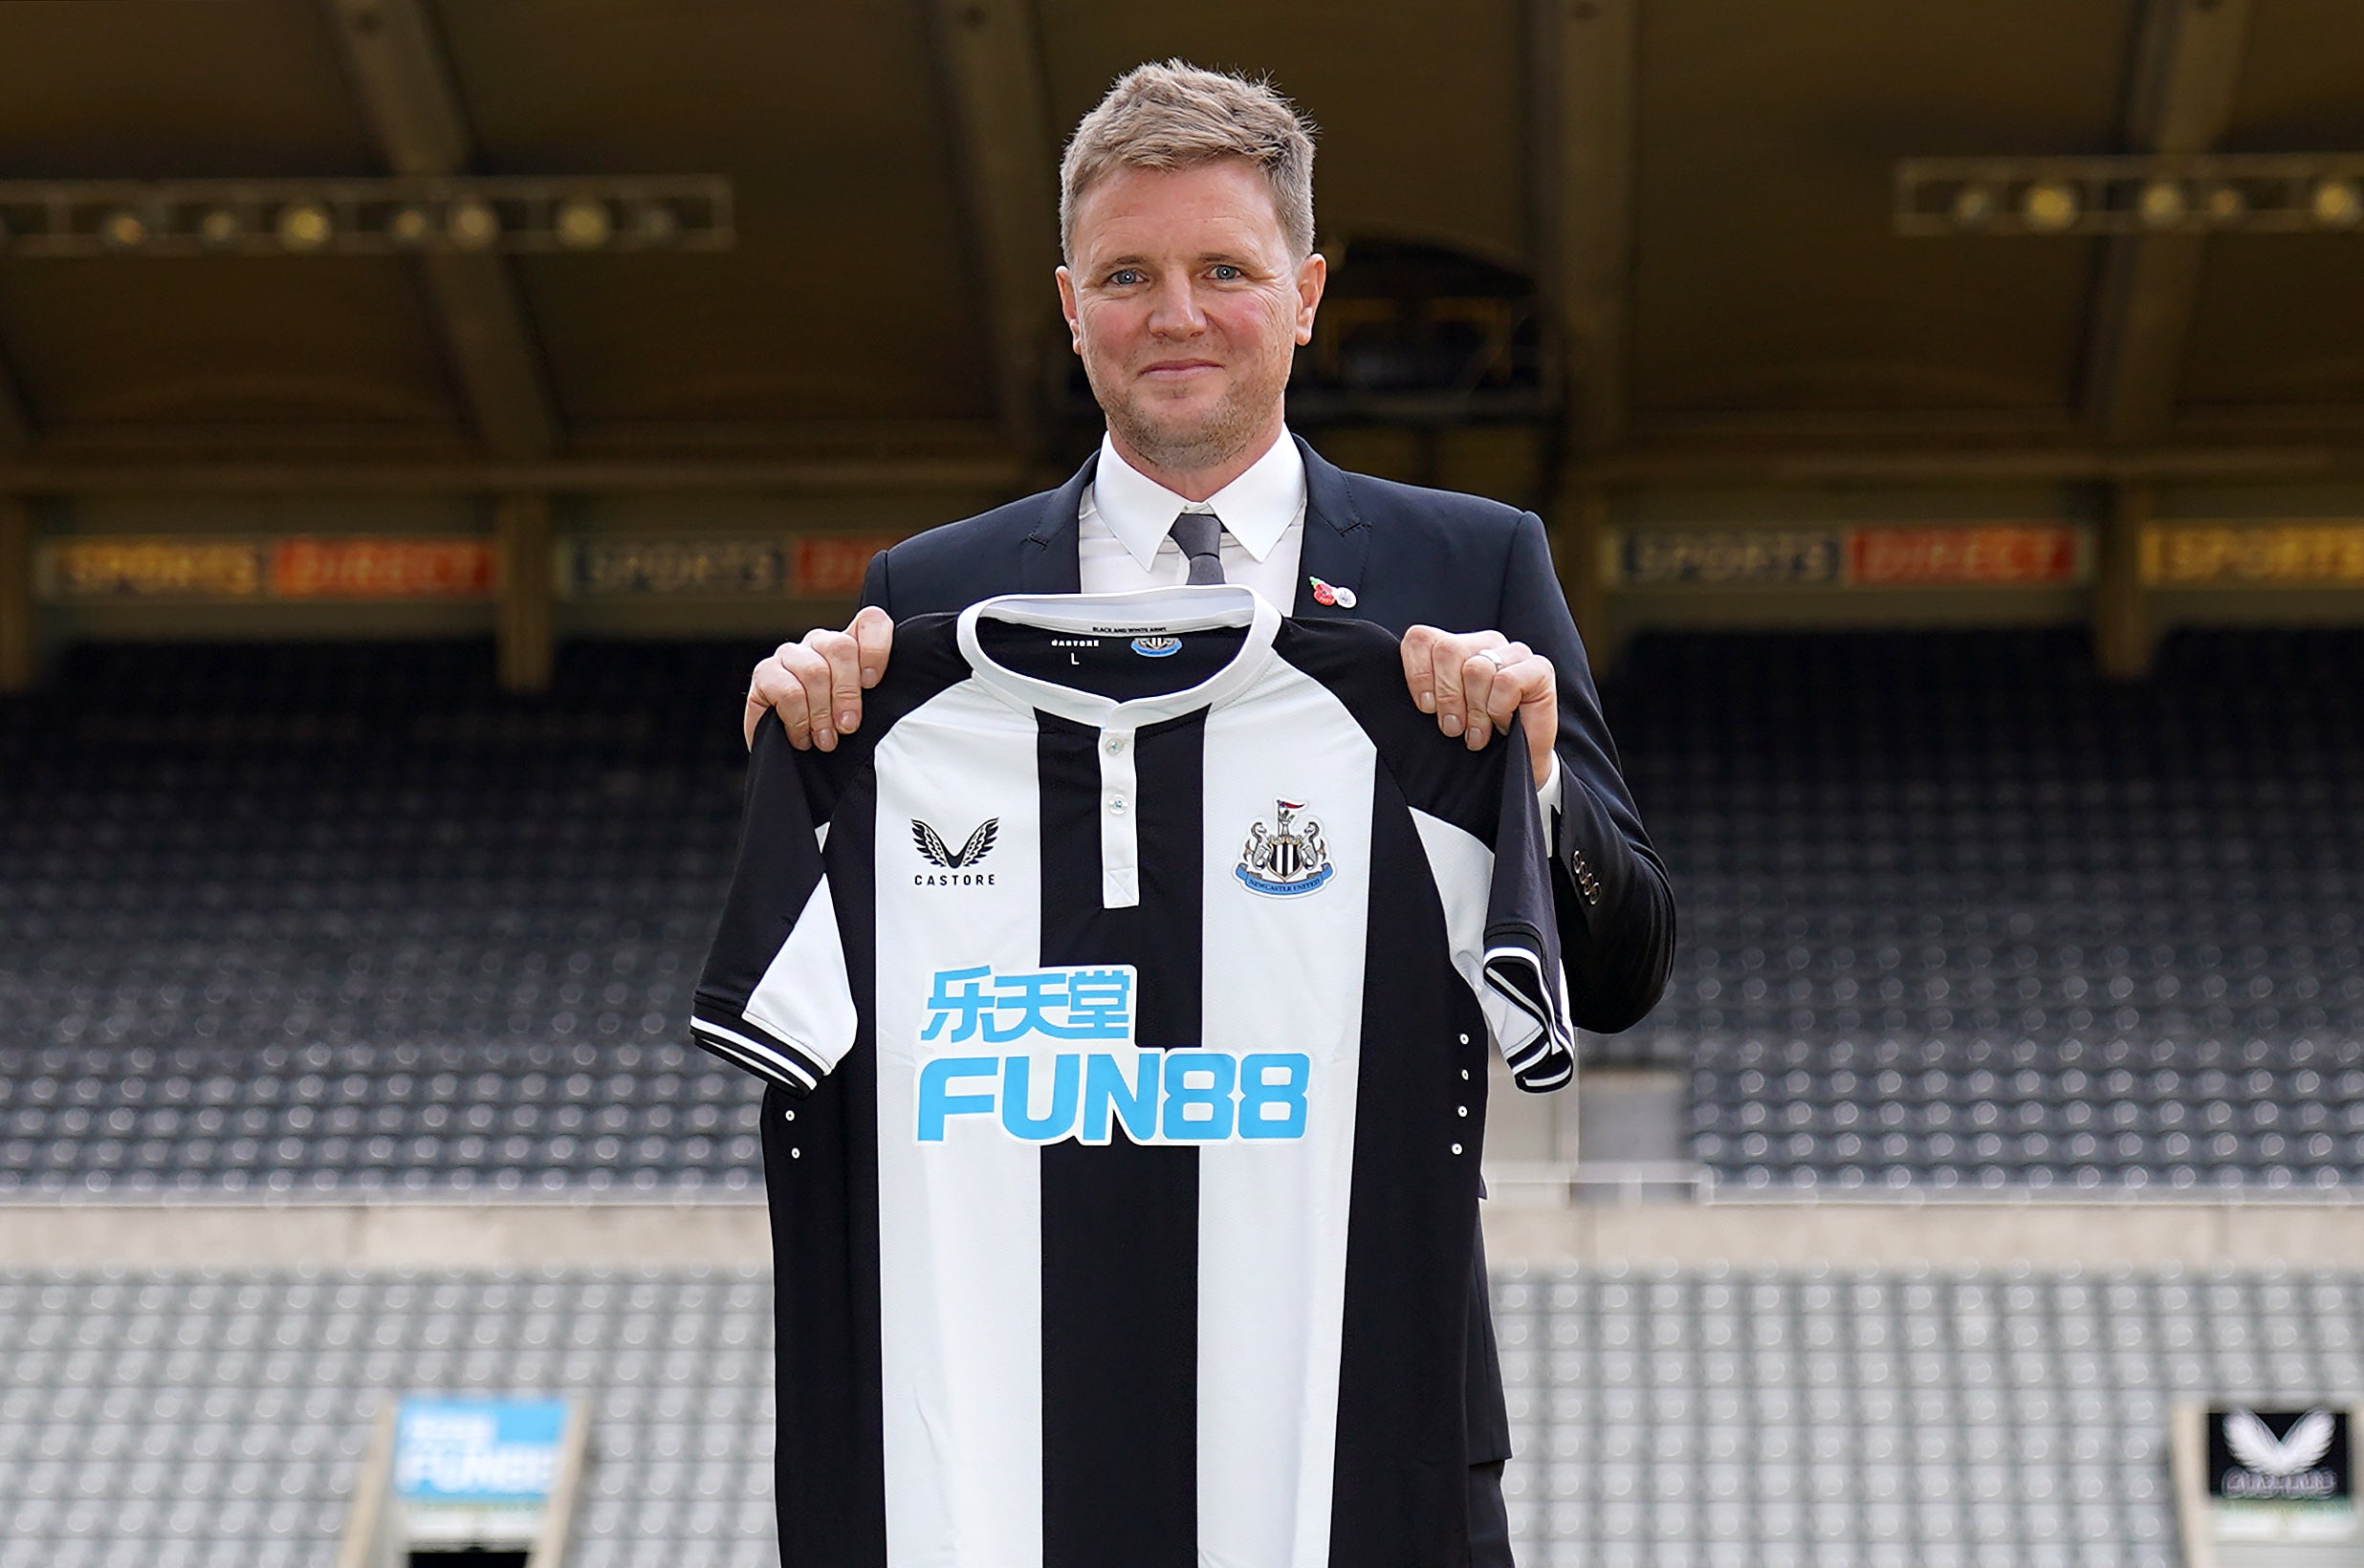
[0,0,2364,1568]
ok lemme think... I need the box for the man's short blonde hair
[1059,59,1314,260]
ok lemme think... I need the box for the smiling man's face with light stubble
[1059,159,1324,473]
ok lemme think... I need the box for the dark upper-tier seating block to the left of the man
[0,643,759,1194]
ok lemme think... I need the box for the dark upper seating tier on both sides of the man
[0,631,2364,1194]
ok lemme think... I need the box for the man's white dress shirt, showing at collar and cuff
[1076,425,1561,813]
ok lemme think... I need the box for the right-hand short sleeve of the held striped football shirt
[1412,724,1577,1093]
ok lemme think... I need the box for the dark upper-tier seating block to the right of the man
[1593,631,2364,1192]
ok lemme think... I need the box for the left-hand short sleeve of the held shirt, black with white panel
[690,719,856,1095]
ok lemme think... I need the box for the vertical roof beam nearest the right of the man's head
[1527,0,1641,454]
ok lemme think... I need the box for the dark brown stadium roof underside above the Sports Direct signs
[0,0,2364,490]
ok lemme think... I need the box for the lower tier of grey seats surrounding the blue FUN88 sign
[0,1270,777,1568]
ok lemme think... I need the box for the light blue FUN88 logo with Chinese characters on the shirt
[917,965,1312,1143]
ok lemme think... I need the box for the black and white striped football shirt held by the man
[692,586,1574,1568]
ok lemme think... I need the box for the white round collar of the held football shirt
[955,584,1281,729]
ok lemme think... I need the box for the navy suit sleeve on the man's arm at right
[1497,513,1674,1034]
